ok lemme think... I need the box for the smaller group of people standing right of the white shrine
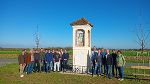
[91,46,125,81]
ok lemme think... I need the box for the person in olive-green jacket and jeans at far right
[116,50,125,81]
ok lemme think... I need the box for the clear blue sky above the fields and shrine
[0,0,150,48]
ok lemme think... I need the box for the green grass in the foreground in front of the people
[0,64,150,84]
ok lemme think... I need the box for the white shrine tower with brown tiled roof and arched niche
[71,18,93,73]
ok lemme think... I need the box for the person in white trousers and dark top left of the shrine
[54,50,61,72]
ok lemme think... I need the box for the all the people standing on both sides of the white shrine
[18,46,125,81]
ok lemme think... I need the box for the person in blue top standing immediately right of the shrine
[91,46,97,77]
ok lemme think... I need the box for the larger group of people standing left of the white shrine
[18,48,69,77]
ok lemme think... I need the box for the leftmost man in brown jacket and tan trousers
[18,50,25,77]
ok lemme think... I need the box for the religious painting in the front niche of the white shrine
[76,29,84,47]
